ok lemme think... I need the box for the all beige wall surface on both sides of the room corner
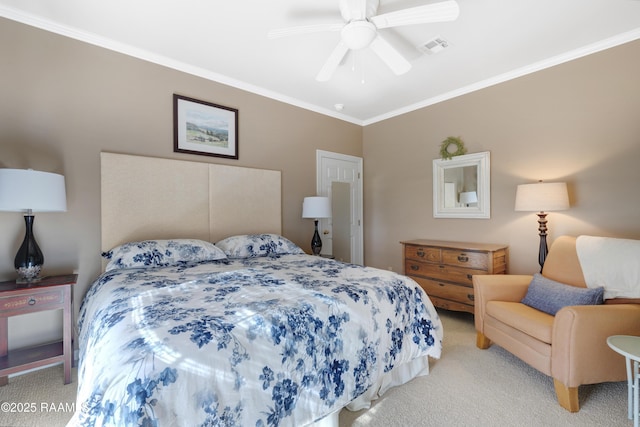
[0,19,640,347]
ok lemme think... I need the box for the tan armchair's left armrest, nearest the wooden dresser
[472,274,533,333]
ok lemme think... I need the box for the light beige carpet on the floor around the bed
[0,310,632,427]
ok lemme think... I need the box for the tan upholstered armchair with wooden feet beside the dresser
[473,236,640,412]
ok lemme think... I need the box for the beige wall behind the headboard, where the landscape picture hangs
[0,19,362,347]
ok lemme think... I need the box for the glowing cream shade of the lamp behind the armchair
[515,182,569,212]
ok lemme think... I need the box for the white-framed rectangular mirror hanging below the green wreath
[433,151,491,218]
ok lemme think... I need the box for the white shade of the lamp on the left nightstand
[0,169,67,212]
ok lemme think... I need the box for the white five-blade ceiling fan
[268,0,460,82]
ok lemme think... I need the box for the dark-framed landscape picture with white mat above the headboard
[173,94,239,160]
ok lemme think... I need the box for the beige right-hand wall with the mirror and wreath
[363,41,640,273]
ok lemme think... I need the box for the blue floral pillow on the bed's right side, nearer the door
[216,234,304,258]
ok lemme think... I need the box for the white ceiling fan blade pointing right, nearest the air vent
[369,0,460,29]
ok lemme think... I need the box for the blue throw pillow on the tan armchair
[521,273,604,316]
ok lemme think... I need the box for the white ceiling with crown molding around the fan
[0,0,640,125]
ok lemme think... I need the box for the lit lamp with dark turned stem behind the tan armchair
[515,181,569,272]
